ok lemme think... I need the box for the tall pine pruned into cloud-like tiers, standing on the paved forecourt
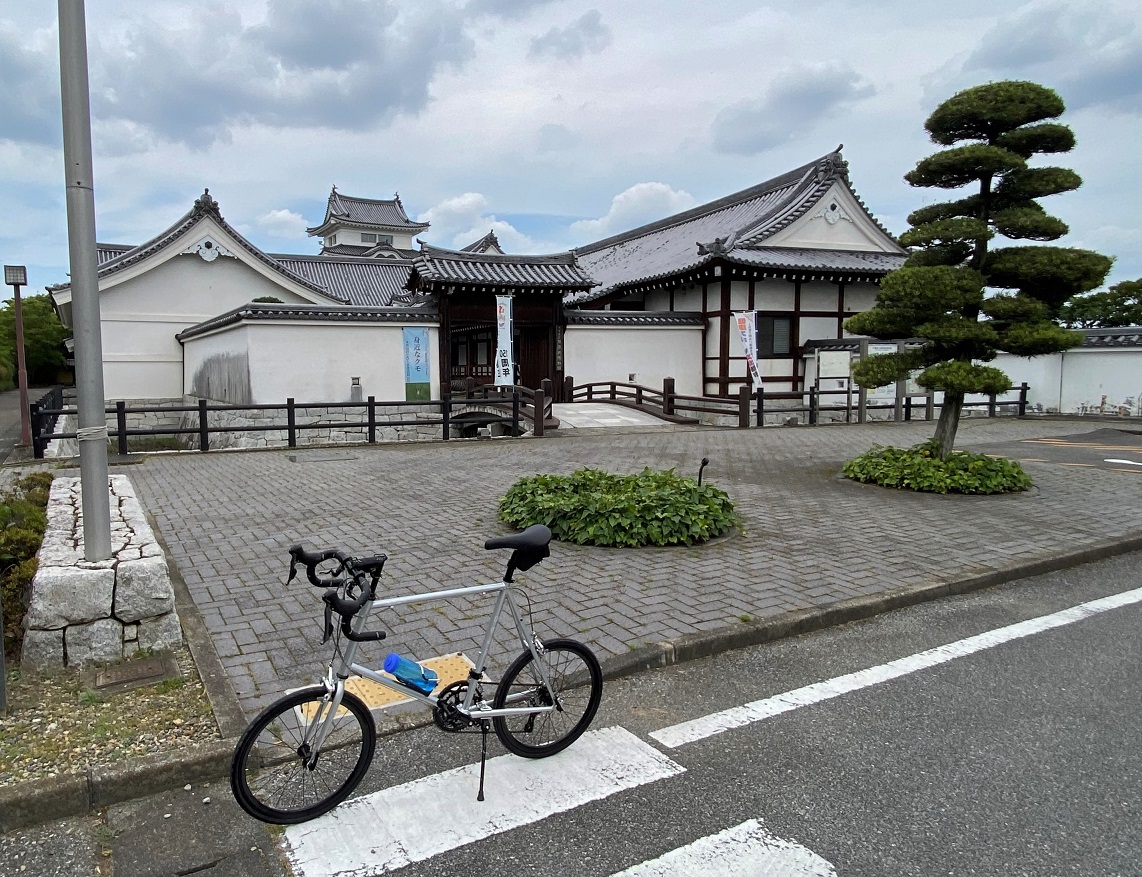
[845,82,1111,457]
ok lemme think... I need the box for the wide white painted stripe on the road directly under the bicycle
[286,727,685,877]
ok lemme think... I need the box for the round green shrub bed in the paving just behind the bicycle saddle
[499,468,737,548]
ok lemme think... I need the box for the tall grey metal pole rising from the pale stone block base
[59,0,111,561]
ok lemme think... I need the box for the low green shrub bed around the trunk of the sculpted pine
[842,441,1031,494]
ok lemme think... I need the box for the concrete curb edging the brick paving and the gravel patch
[0,529,1142,831]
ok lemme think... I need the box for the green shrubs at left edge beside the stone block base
[0,472,54,657]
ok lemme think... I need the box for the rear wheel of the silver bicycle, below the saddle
[492,639,603,758]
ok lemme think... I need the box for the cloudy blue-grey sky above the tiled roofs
[0,0,1142,295]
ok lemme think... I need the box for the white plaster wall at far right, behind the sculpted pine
[990,348,1142,417]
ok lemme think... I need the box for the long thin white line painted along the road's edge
[650,588,1142,749]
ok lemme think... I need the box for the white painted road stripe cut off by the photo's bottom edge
[611,819,837,877]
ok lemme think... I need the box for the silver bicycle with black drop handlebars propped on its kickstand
[230,524,603,824]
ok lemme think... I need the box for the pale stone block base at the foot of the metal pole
[21,475,183,670]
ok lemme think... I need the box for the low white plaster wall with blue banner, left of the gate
[249,321,440,404]
